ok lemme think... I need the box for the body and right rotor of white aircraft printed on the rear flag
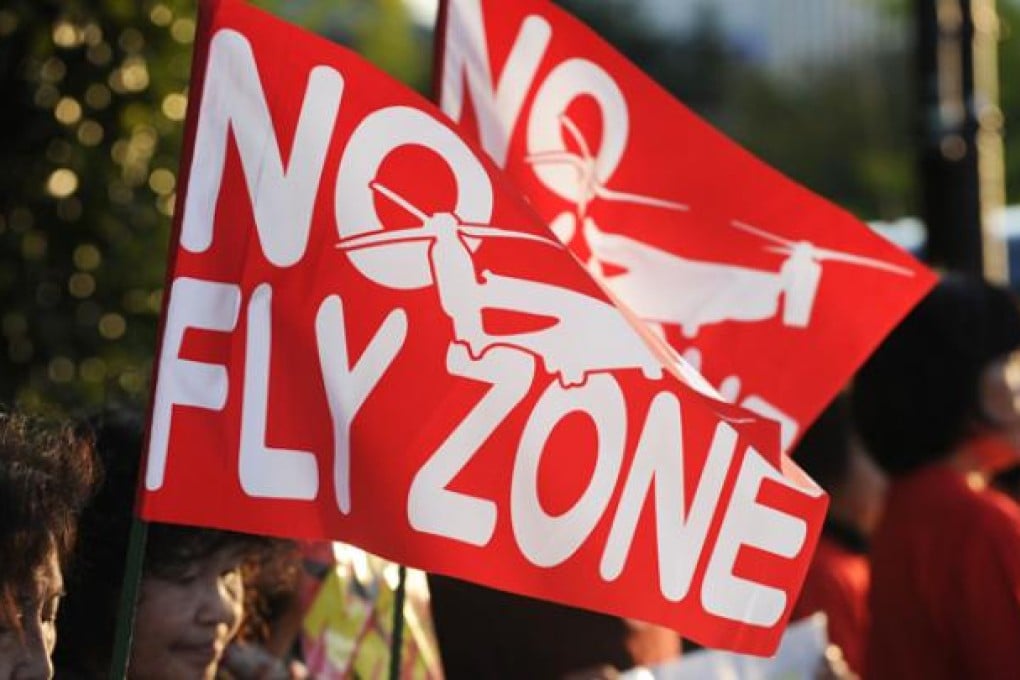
[584,218,914,338]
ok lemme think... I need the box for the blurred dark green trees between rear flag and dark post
[558,0,917,219]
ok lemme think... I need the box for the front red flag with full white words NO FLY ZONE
[142,0,826,652]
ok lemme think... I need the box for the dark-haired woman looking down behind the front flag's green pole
[54,412,301,680]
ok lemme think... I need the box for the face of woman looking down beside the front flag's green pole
[129,547,244,680]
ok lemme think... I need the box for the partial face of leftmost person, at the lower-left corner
[0,548,63,680]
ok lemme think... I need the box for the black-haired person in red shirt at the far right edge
[853,277,1020,680]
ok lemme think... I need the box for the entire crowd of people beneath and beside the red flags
[0,276,1020,680]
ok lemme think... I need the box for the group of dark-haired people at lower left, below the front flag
[0,413,302,680]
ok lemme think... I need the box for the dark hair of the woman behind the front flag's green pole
[53,411,281,678]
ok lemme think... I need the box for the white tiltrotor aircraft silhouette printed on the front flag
[337,181,663,386]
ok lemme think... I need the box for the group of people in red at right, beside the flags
[795,276,1020,680]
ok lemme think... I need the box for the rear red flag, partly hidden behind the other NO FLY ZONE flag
[437,0,933,448]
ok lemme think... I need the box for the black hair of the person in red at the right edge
[853,275,1020,475]
